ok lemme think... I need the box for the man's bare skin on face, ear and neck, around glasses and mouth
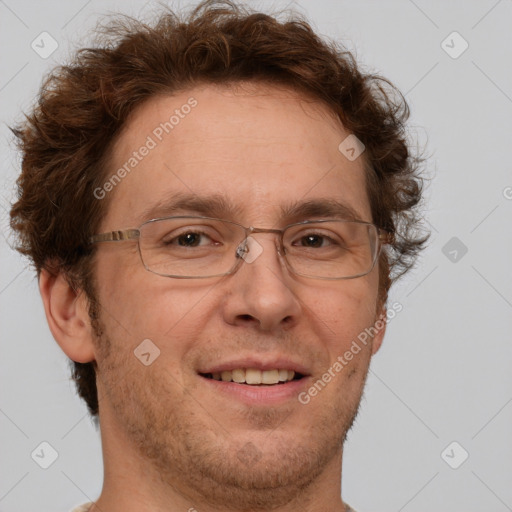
[40,84,384,512]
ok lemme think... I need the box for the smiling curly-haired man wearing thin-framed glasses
[11,2,425,512]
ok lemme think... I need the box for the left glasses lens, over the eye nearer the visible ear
[139,217,245,277]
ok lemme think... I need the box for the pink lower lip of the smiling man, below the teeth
[198,374,311,406]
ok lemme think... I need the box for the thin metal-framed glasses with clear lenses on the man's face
[90,216,393,279]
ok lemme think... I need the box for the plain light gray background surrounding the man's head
[0,0,512,512]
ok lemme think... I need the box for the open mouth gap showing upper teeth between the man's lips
[199,368,306,387]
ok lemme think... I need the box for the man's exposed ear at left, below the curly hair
[39,270,95,363]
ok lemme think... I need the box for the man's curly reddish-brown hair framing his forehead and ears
[11,0,428,416]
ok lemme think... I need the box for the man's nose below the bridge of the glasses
[219,234,301,332]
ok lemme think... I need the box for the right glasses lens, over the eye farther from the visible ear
[283,221,378,279]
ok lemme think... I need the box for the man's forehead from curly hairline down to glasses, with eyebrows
[103,84,371,229]
